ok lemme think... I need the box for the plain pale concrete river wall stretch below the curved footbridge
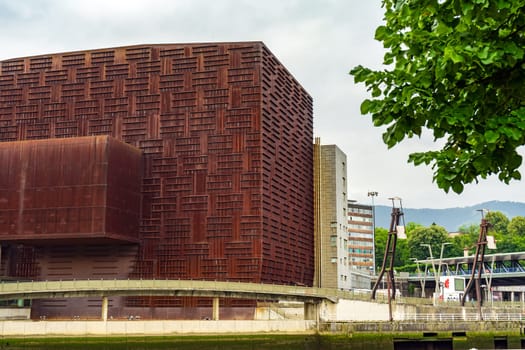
[0,320,316,337]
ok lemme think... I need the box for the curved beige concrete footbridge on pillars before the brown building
[0,279,349,320]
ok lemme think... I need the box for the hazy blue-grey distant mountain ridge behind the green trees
[375,201,525,232]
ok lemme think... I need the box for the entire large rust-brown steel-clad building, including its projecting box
[0,42,314,317]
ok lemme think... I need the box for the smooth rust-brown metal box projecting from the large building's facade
[0,136,140,243]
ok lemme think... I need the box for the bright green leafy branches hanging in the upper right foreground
[350,0,525,193]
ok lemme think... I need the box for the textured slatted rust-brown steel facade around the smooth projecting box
[0,42,314,318]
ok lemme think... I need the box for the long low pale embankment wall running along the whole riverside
[0,320,522,338]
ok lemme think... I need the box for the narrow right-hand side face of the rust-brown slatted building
[261,45,314,285]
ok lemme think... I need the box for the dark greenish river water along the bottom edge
[0,334,520,350]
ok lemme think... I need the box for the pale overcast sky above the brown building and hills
[0,0,525,209]
